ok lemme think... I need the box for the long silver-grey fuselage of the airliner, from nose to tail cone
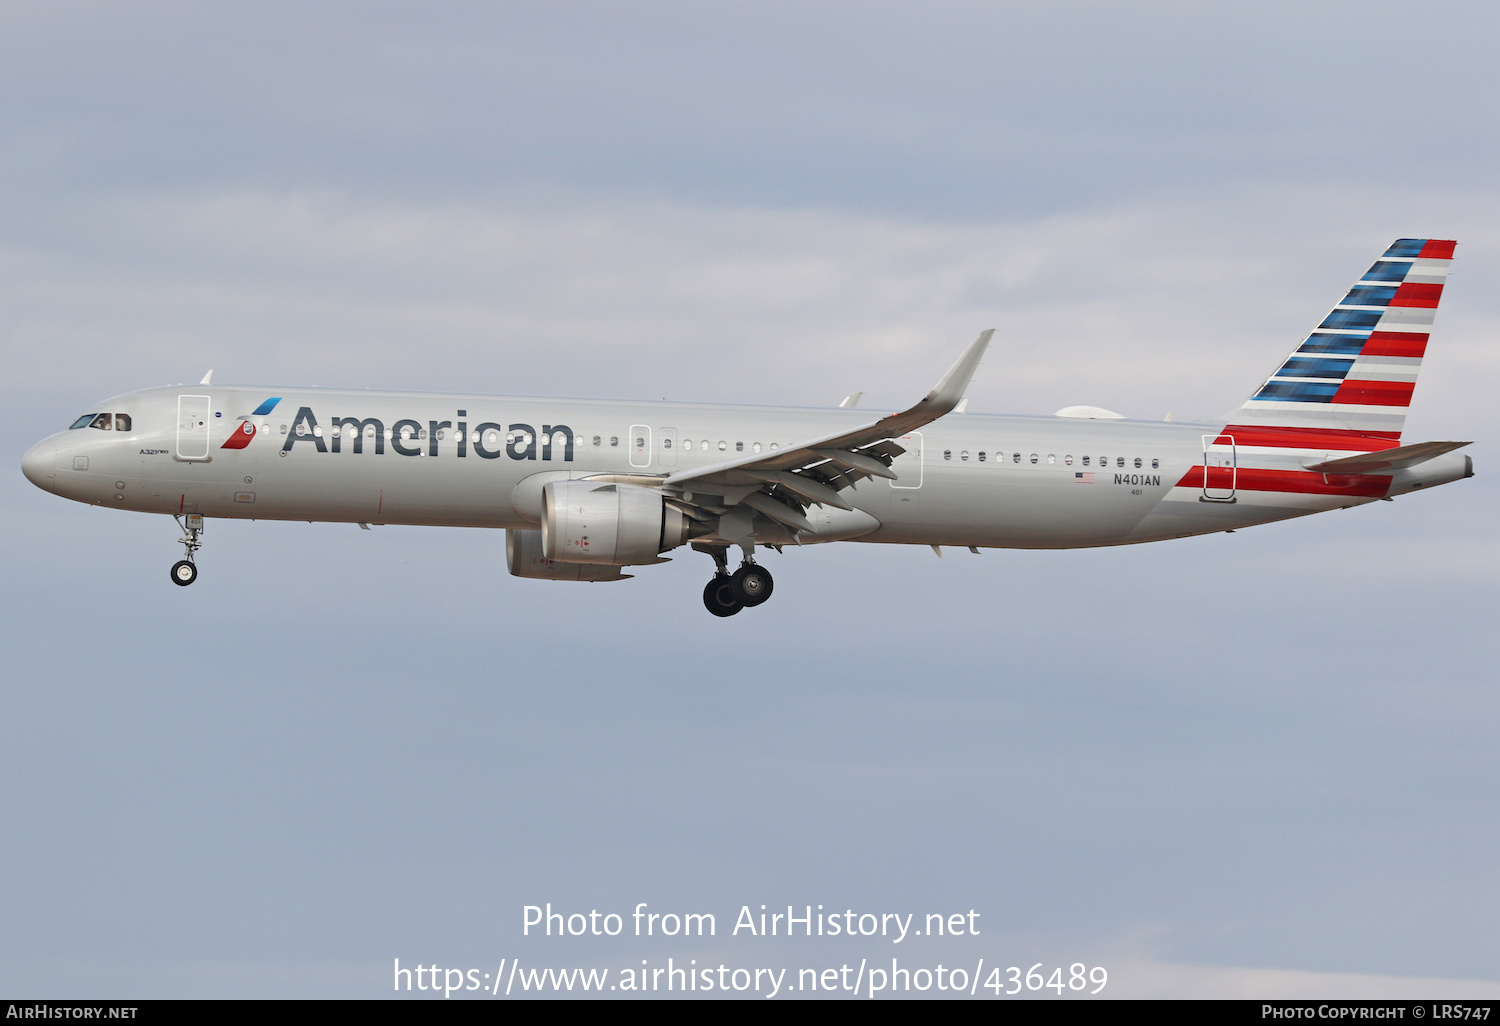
[24,386,1470,549]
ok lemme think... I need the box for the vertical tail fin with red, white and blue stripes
[1226,239,1457,450]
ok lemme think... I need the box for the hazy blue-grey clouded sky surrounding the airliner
[0,3,1500,996]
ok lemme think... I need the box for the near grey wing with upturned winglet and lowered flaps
[639,329,995,531]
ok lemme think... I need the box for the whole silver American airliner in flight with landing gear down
[21,239,1475,617]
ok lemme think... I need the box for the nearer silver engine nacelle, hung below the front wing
[542,480,692,567]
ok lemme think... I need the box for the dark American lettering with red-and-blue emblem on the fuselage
[273,399,573,464]
